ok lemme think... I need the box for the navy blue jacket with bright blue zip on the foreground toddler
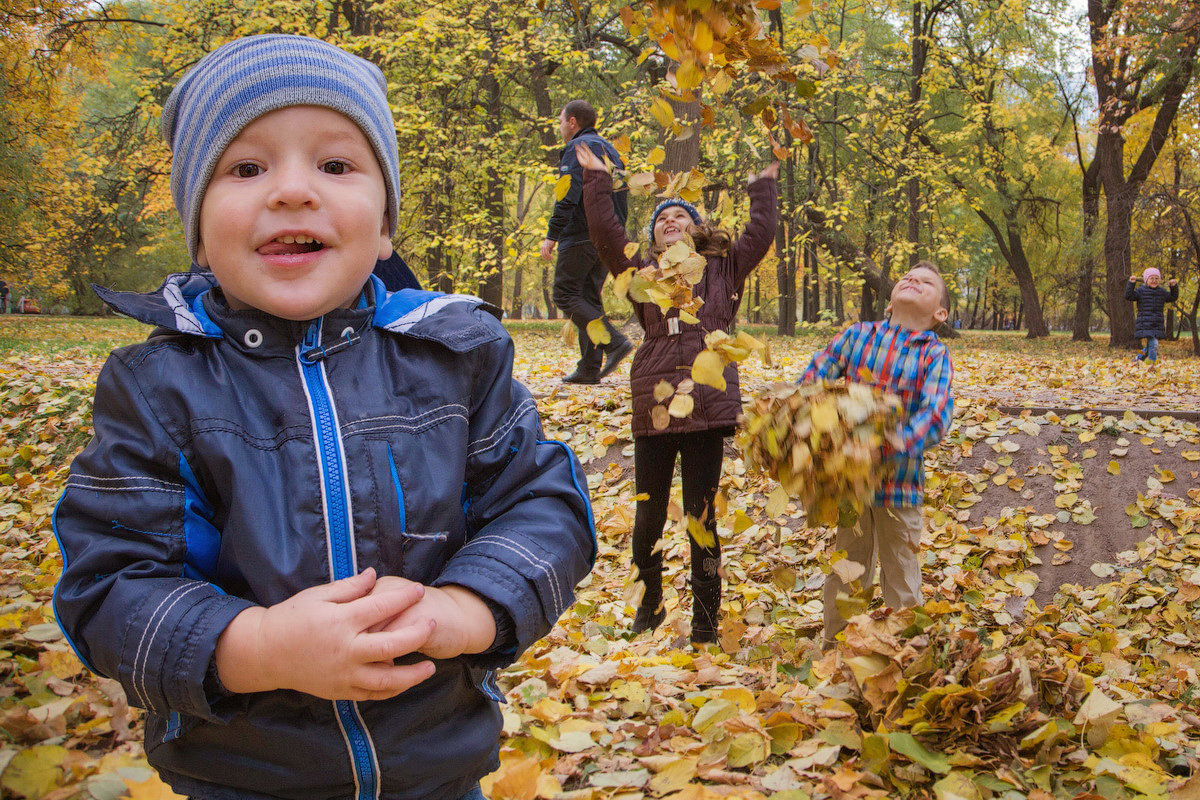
[54,273,595,800]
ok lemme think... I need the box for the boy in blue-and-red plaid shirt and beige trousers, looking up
[800,261,954,642]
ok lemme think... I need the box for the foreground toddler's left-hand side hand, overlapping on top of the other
[216,569,434,700]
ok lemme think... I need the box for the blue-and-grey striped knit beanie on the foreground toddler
[162,34,400,259]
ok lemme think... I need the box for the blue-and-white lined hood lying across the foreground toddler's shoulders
[91,272,502,353]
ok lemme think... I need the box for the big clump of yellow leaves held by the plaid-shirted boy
[737,383,900,525]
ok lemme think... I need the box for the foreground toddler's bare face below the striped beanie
[196,106,391,320]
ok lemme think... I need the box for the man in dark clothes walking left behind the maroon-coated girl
[541,100,634,384]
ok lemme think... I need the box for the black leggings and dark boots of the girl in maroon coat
[634,429,728,630]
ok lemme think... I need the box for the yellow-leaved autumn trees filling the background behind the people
[0,0,1200,354]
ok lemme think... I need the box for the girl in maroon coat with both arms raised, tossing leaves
[576,148,779,644]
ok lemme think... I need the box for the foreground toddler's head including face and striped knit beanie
[162,35,398,320]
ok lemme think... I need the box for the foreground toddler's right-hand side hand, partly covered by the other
[376,577,496,658]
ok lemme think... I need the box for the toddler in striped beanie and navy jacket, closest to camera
[55,36,595,800]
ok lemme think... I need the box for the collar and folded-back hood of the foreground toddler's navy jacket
[92,272,500,353]
